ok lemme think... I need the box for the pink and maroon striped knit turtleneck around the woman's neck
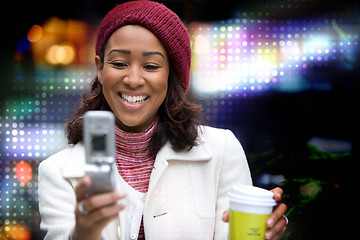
[115,118,158,193]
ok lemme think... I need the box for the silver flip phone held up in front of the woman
[83,111,115,196]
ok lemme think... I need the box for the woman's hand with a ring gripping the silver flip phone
[73,176,126,240]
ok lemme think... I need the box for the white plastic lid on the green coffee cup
[228,185,276,207]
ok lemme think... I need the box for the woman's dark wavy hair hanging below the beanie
[66,63,203,156]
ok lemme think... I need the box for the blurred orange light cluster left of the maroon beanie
[27,17,95,66]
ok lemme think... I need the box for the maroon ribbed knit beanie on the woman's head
[96,0,191,92]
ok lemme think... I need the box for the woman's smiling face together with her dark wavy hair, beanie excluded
[67,22,202,156]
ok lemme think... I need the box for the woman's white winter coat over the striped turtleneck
[39,127,252,240]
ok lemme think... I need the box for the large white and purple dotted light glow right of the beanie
[190,18,360,94]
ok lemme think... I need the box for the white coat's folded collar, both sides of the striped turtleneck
[62,138,212,178]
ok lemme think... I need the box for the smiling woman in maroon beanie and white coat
[39,1,286,240]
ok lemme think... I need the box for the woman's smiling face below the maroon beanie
[95,25,169,132]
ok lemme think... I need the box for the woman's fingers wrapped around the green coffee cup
[222,187,287,240]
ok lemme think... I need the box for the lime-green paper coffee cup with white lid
[228,185,276,240]
